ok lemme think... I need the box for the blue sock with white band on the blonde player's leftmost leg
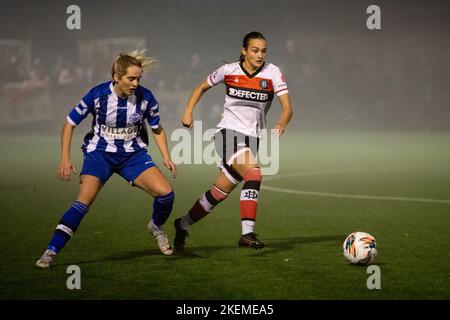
[48,201,89,252]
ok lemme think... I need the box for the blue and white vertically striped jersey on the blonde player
[67,81,159,152]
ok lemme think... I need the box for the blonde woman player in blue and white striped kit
[36,51,176,268]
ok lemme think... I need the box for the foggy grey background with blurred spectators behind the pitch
[0,0,450,134]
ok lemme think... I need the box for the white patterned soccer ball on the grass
[343,232,377,265]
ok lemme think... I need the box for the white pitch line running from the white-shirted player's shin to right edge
[261,186,450,204]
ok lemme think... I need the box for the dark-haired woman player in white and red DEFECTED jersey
[174,32,292,252]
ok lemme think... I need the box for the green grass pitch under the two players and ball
[0,132,450,300]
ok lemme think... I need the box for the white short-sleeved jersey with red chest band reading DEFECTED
[207,62,288,137]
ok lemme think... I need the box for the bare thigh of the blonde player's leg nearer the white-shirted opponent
[133,166,172,197]
